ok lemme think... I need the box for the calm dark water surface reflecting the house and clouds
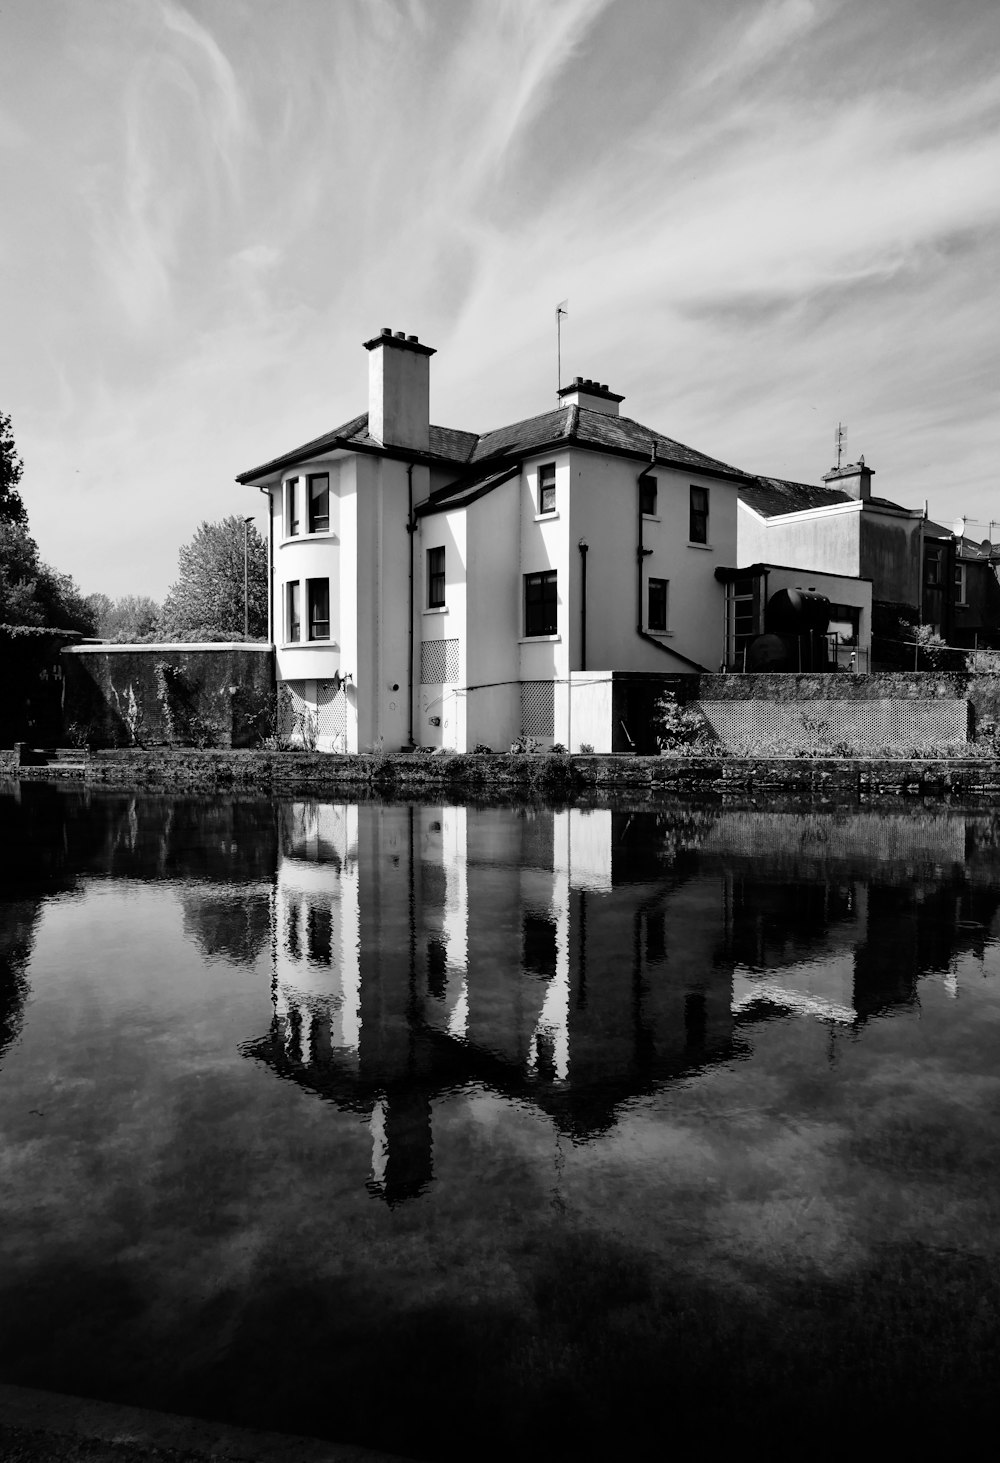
[0,784,1000,1459]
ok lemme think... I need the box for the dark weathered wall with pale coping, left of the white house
[61,644,275,746]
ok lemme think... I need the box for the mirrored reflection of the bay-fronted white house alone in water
[244,803,734,1203]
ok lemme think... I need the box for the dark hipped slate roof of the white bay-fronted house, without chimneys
[237,407,748,496]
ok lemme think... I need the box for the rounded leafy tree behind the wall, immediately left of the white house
[159,514,268,641]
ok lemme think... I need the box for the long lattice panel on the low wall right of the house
[694,698,968,755]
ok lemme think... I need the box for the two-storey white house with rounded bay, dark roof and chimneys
[237,329,857,751]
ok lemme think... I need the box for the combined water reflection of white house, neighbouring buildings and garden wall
[244,802,1000,1203]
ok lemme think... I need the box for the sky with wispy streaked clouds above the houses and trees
[0,0,1000,597]
